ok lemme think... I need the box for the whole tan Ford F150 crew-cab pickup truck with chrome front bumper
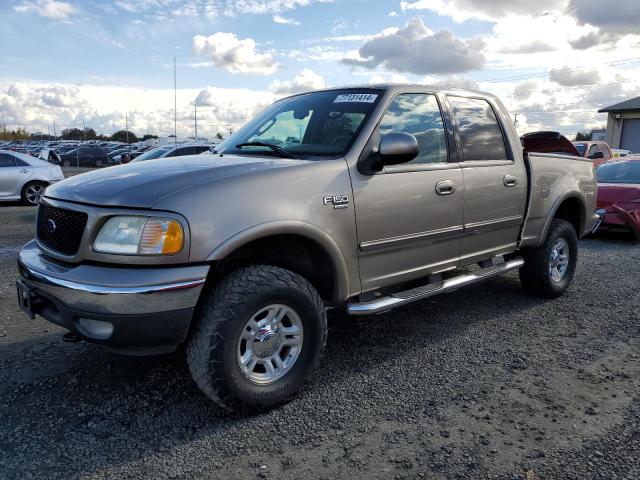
[18,85,598,408]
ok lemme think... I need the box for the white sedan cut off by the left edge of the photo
[0,150,64,205]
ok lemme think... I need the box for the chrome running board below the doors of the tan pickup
[347,257,524,315]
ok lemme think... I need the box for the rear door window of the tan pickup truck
[448,96,509,161]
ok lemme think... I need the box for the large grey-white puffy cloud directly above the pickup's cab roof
[343,18,486,74]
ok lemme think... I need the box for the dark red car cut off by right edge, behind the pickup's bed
[596,155,640,240]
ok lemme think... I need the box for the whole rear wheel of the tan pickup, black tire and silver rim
[520,218,578,298]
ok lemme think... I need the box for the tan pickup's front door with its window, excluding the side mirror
[352,93,464,291]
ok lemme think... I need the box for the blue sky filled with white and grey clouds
[0,0,640,137]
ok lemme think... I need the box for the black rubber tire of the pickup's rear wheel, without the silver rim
[520,218,578,298]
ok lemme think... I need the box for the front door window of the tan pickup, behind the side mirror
[380,93,448,164]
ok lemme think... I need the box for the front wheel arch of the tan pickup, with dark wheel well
[207,221,349,303]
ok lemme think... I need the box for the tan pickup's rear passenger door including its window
[447,95,527,265]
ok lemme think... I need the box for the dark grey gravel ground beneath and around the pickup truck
[0,206,640,480]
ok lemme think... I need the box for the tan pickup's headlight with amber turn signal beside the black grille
[93,217,184,255]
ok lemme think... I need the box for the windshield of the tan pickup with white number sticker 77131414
[221,88,383,158]
